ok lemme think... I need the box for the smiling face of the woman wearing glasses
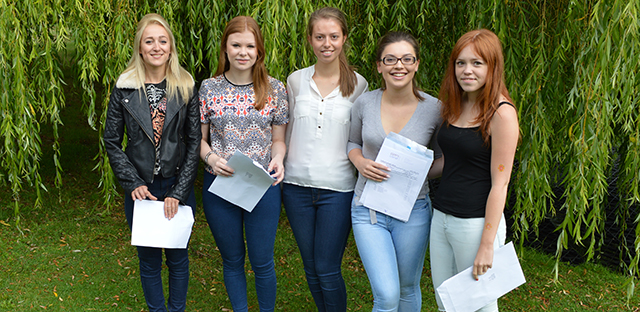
[377,41,420,89]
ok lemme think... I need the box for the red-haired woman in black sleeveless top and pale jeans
[430,29,519,311]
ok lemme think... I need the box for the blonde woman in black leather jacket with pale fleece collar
[104,14,201,311]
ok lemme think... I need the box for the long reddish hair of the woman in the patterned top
[214,16,271,110]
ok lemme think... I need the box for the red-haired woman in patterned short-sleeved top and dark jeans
[200,16,289,312]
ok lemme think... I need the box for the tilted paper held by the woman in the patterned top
[209,151,276,212]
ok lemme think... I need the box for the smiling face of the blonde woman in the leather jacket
[139,24,171,69]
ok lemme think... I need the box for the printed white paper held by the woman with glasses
[360,132,433,222]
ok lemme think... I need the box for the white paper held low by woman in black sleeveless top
[437,242,526,312]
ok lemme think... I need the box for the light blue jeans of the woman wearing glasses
[351,196,431,312]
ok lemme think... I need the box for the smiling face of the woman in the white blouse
[307,18,347,63]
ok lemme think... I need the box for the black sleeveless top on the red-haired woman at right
[433,102,513,218]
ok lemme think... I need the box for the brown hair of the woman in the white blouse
[307,7,357,97]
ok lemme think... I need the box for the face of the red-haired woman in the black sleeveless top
[455,45,488,95]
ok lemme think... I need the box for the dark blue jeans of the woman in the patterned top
[202,171,281,312]
